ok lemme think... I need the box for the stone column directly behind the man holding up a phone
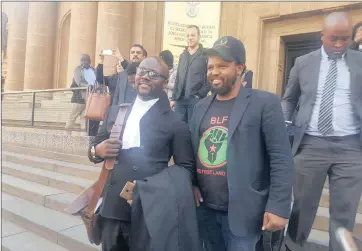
[94,2,133,75]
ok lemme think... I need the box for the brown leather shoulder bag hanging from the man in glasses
[65,104,129,245]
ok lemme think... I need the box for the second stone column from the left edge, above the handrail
[24,2,58,90]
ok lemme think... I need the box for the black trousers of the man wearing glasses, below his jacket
[102,217,131,251]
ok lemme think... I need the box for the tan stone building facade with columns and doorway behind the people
[2,2,362,95]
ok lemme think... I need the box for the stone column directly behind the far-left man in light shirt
[67,2,98,87]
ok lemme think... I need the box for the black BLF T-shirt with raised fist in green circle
[197,98,235,211]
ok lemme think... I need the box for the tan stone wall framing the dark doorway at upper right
[220,2,362,94]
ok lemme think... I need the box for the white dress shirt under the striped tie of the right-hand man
[306,47,361,136]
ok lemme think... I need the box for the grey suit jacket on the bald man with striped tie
[282,49,362,155]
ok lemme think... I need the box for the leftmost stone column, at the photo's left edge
[3,2,29,91]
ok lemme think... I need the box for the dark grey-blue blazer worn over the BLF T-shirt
[189,87,294,236]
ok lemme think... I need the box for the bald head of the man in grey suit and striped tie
[322,12,352,58]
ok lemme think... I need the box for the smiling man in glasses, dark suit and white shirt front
[89,57,195,251]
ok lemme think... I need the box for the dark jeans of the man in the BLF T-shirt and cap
[197,205,260,251]
